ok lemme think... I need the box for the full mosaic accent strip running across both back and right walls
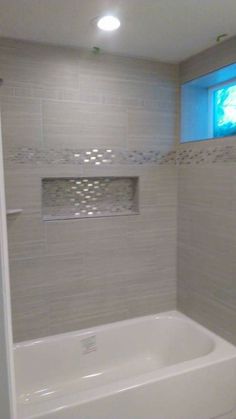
[4,143,236,167]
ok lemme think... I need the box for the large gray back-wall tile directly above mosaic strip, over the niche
[42,101,127,148]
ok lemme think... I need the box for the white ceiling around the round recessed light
[0,0,236,62]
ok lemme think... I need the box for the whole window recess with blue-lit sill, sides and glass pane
[180,62,236,143]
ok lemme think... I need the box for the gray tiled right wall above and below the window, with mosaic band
[178,38,236,344]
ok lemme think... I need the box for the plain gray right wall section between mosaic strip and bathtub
[178,163,236,343]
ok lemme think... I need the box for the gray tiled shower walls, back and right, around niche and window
[0,38,236,344]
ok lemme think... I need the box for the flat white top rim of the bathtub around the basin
[14,310,236,419]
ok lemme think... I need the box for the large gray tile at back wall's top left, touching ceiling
[0,38,79,89]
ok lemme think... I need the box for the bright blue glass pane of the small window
[213,83,236,137]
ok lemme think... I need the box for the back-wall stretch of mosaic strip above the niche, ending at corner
[5,147,175,167]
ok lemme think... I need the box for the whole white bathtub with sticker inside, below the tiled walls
[14,312,236,419]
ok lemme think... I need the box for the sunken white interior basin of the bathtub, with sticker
[15,313,214,404]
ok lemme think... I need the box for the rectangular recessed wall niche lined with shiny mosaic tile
[42,177,138,221]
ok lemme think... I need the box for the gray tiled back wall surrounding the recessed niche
[0,39,178,341]
